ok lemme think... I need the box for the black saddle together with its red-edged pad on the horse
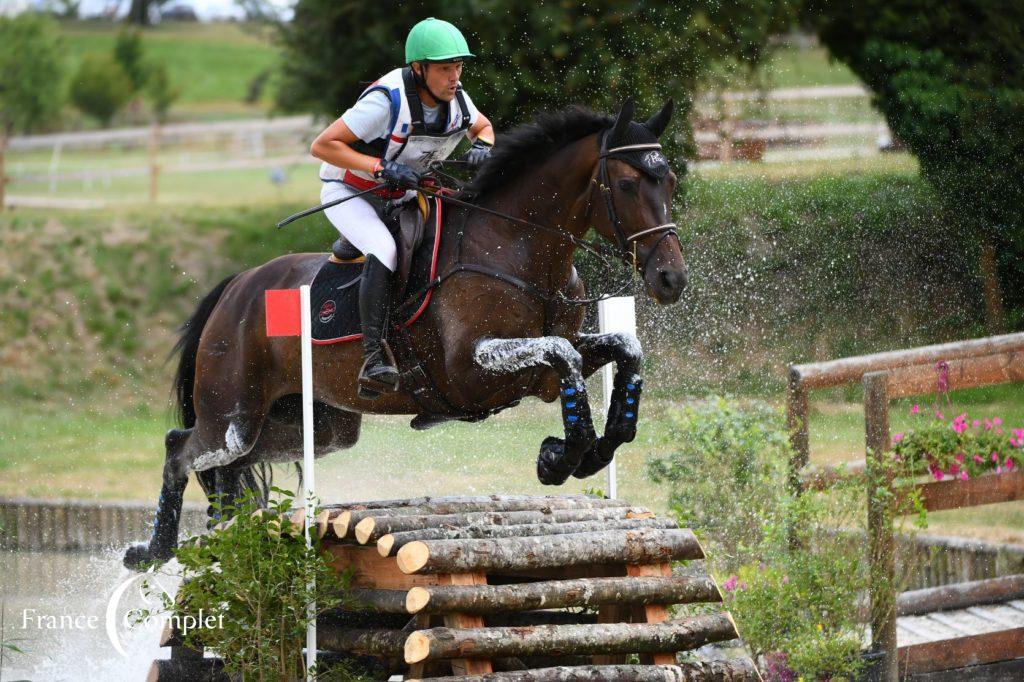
[309,195,441,345]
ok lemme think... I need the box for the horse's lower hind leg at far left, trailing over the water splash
[124,429,189,569]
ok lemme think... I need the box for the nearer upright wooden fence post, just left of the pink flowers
[863,372,898,682]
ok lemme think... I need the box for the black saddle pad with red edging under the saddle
[309,200,441,345]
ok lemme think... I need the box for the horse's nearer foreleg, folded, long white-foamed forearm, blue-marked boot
[473,336,597,485]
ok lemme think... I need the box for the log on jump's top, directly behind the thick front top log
[377,514,679,556]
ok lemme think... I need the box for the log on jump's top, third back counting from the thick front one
[354,507,653,545]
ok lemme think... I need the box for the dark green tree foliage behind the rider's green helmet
[278,0,793,156]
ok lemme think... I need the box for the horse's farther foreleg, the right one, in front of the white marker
[572,333,643,478]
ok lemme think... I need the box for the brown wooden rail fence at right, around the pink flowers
[786,333,1024,680]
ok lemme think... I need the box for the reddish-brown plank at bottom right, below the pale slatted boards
[898,628,1024,675]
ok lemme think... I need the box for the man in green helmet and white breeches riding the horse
[310,17,495,398]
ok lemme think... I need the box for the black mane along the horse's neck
[465,105,615,198]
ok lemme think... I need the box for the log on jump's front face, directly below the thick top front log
[406,576,722,613]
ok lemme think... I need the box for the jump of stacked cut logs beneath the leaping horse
[148,496,761,682]
